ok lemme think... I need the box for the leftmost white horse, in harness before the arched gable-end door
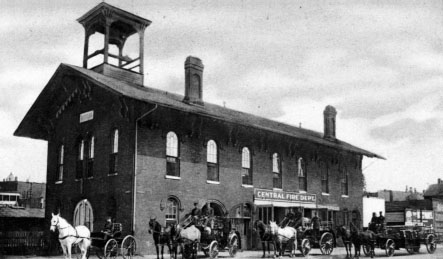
[50,214,91,259]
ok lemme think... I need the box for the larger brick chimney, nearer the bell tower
[183,56,204,105]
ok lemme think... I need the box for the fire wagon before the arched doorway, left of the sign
[181,216,240,259]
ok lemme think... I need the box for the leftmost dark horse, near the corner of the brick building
[149,218,177,259]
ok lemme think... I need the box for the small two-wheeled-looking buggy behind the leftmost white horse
[88,223,137,259]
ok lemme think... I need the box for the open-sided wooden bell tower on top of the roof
[77,2,151,85]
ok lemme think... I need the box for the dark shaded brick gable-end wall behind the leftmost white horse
[46,82,134,236]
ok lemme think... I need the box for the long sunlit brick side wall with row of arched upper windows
[135,105,363,252]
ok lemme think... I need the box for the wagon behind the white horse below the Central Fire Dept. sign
[297,221,336,256]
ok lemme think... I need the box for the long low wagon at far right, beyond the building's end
[363,226,437,257]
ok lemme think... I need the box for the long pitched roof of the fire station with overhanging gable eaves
[14,64,385,159]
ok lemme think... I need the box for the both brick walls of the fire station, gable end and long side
[46,80,363,253]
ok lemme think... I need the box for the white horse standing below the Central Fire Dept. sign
[269,221,297,258]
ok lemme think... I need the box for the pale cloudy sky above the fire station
[0,0,443,191]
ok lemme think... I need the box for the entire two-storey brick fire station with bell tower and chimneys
[14,3,379,252]
